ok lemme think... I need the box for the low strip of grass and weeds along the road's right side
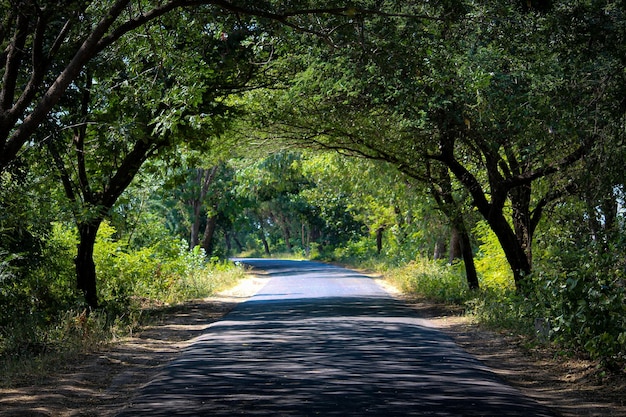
[359,258,626,374]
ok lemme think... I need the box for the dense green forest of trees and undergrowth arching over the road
[0,0,626,371]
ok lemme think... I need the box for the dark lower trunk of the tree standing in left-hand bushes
[74,219,102,310]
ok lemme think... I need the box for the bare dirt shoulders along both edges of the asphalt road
[0,278,626,417]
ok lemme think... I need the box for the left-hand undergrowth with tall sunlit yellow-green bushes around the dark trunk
[0,224,245,385]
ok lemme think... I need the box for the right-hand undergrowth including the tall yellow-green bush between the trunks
[333,231,626,372]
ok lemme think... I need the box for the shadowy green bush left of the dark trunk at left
[0,223,100,357]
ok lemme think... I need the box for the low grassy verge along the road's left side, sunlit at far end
[0,262,245,388]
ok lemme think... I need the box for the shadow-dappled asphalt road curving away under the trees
[119,259,554,417]
